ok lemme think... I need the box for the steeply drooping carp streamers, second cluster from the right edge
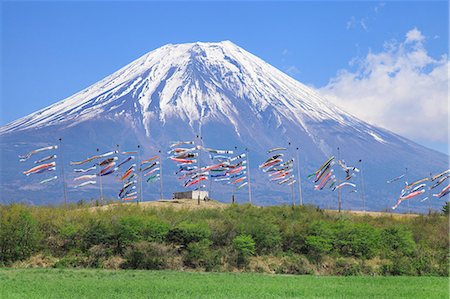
[308,156,359,192]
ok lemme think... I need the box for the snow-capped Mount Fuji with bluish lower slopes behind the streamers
[0,41,449,211]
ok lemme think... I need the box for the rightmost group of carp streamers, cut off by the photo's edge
[387,169,450,210]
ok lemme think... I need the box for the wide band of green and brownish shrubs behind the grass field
[0,205,449,276]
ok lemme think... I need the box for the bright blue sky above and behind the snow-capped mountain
[0,1,448,152]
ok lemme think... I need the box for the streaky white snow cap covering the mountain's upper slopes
[0,41,358,137]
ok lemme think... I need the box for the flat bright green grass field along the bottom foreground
[0,269,448,299]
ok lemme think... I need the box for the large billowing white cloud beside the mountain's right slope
[320,28,449,143]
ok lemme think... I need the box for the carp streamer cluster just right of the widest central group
[259,147,297,186]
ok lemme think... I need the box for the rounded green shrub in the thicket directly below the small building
[167,222,211,247]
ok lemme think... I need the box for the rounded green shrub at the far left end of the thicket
[0,205,41,264]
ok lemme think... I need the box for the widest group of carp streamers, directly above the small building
[168,141,248,190]
